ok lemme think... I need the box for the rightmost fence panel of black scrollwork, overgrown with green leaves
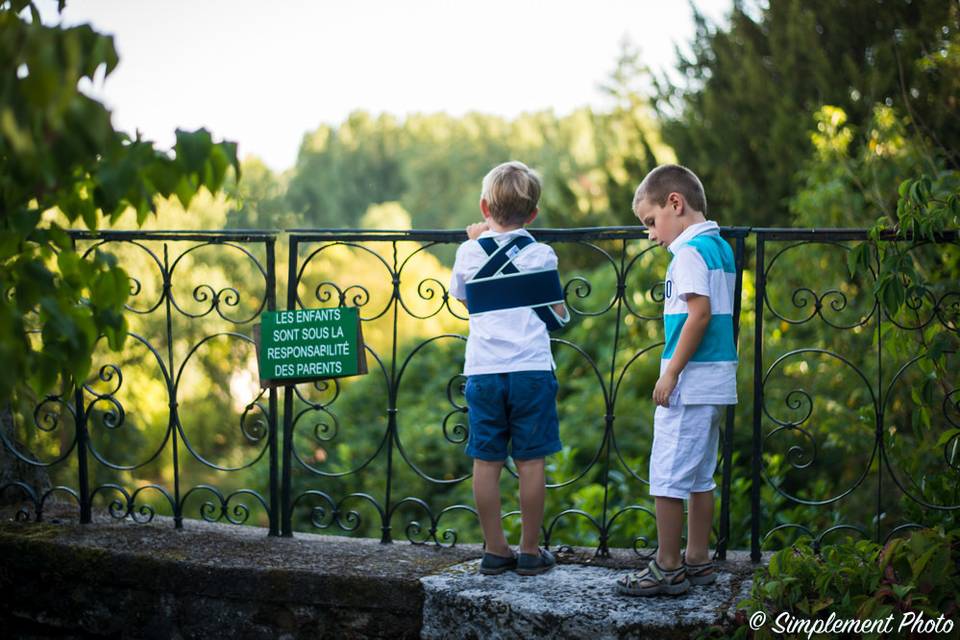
[741,229,960,559]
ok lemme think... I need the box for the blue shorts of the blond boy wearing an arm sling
[466,371,563,462]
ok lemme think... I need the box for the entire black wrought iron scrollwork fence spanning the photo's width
[0,227,960,559]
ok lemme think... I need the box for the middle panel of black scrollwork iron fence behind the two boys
[281,227,747,557]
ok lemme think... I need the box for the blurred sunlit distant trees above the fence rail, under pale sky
[278,39,672,229]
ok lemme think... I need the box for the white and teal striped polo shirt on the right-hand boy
[660,221,737,405]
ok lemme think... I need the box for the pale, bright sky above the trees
[39,0,732,170]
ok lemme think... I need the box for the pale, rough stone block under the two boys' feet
[421,552,752,640]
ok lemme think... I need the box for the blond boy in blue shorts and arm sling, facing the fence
[450,162,566,575]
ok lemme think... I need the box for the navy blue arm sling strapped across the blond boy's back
[467,236,570,331]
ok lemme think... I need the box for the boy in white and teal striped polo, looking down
[618,165,737,595]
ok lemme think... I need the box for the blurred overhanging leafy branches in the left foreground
[0,1,239,403]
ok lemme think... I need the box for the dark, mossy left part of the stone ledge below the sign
[0,519,480,638]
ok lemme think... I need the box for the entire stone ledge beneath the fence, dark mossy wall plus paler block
[0,512,756,638]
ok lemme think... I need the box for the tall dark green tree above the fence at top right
[655,0,960,226]
